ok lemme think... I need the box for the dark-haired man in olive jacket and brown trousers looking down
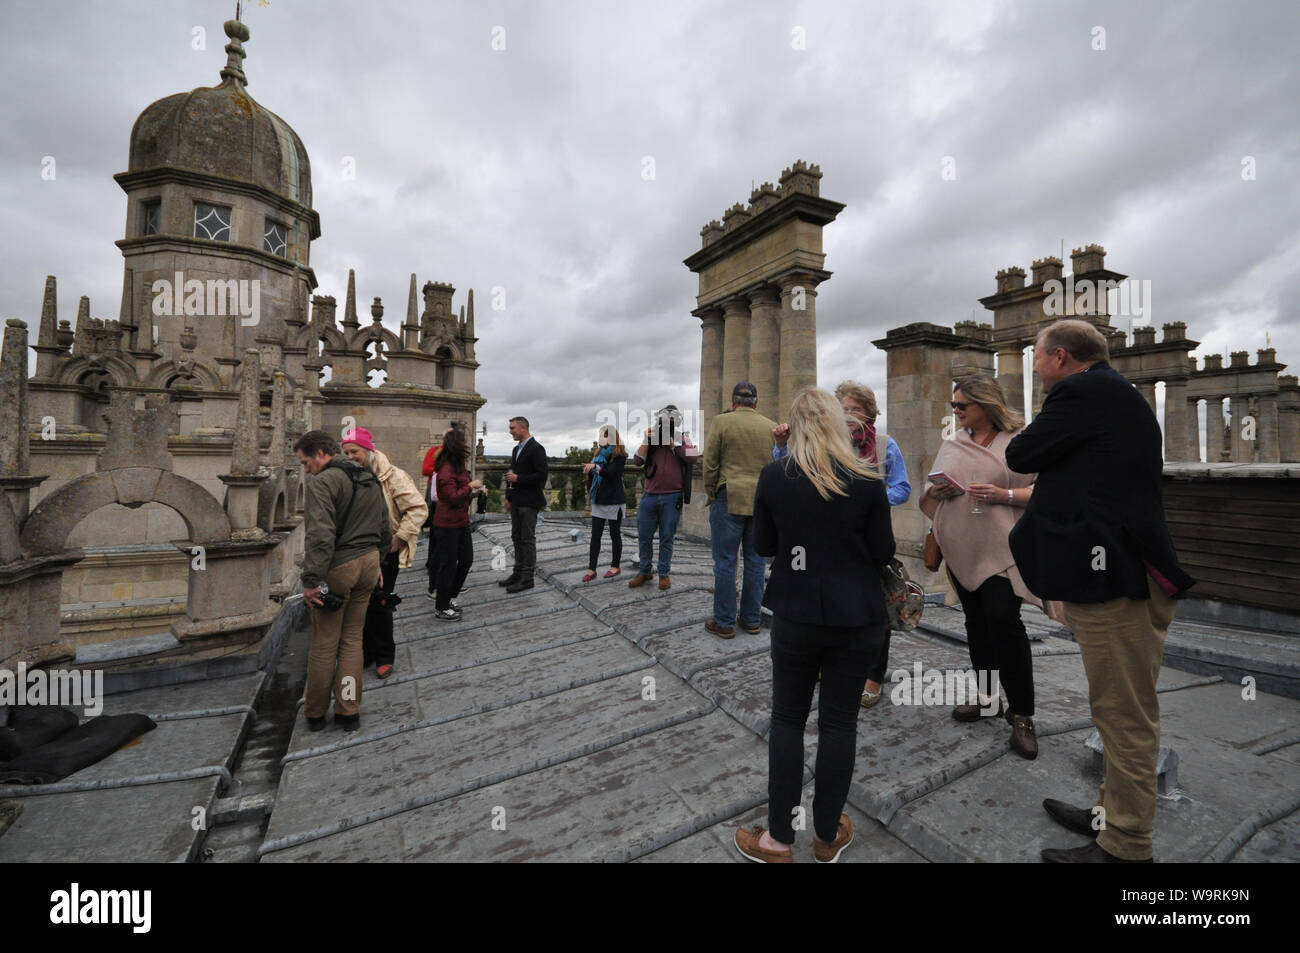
[294,430,393,731]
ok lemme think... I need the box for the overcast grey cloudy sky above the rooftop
[0,0,1300,454]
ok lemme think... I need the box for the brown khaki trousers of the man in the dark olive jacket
[304,550,380,718]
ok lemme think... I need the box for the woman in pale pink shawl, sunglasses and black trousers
[920,374,1043,758]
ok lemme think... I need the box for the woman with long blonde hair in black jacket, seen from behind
[736,387,894,863]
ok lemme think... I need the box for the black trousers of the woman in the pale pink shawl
[948,572,1034,715]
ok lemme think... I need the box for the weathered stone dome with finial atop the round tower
[129,20,312,208]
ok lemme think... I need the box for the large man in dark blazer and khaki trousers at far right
[1006,320,1195,863]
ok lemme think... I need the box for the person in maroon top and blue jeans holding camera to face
[628,404,699,589]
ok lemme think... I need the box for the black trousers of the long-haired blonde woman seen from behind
[767,615,889,844]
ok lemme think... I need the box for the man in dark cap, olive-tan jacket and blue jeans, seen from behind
[705,381,776,638]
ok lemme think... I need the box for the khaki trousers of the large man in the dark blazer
[1065,577,1175,861]
